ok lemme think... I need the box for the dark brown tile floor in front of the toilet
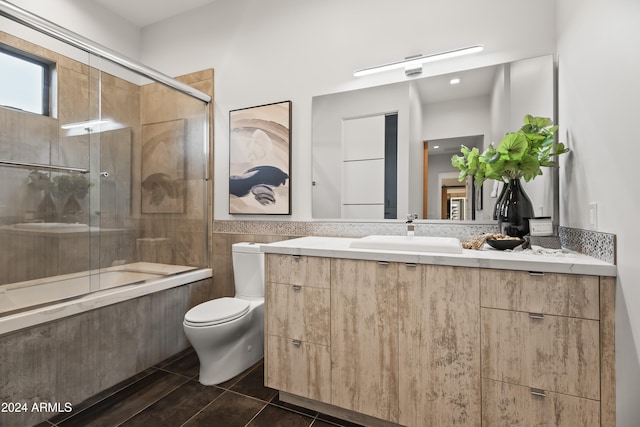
[40,349,359,427]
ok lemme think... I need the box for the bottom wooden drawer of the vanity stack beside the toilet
[264,335,331,403]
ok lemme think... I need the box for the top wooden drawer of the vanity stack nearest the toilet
[265,254,331,288]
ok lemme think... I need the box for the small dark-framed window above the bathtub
[0,45,51,116]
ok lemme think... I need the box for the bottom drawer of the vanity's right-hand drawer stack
[482,380,600,427]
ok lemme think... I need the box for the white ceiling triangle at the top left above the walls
[93,0,215,28]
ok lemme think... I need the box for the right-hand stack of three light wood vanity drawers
[480,269,615,426]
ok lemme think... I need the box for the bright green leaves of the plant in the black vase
[451,114,569,186]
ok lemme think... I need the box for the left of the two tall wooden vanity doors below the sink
[331,259,398,422]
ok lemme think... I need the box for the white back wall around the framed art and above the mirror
[142,0,555,220]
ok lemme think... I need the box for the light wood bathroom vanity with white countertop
[261,237,616,427]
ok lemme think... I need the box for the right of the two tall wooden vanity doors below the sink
[398,264,481,426]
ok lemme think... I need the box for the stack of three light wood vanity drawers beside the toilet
[265,254,331,402]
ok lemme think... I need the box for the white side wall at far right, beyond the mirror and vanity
[556,0,640,427]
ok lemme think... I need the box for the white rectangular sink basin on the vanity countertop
[349,236,462,254]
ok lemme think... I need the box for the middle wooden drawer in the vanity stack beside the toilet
[265,283,331,345]
